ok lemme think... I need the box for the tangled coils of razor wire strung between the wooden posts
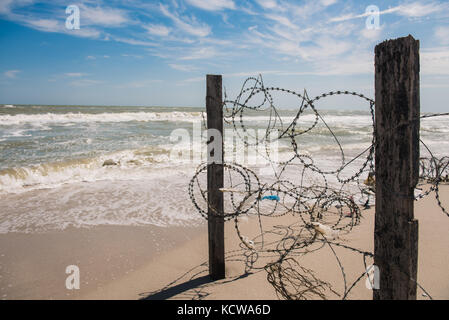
[188,76,449,300]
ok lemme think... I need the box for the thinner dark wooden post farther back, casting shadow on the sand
[206,75,225,280]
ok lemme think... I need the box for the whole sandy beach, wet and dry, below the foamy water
[0,185,449,299]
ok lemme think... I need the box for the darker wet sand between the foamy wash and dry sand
[0,226,204,300]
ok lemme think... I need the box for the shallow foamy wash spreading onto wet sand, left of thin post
[0,176,203,233]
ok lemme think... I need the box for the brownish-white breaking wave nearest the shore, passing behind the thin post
[0,142,318,194]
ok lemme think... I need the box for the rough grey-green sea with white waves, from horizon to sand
[0,105,449,233]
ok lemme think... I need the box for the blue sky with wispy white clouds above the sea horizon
[0,0,449,111]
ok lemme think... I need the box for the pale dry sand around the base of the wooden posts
[81,187,449,300]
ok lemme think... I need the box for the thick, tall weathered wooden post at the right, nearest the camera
[373,35,420,300]
